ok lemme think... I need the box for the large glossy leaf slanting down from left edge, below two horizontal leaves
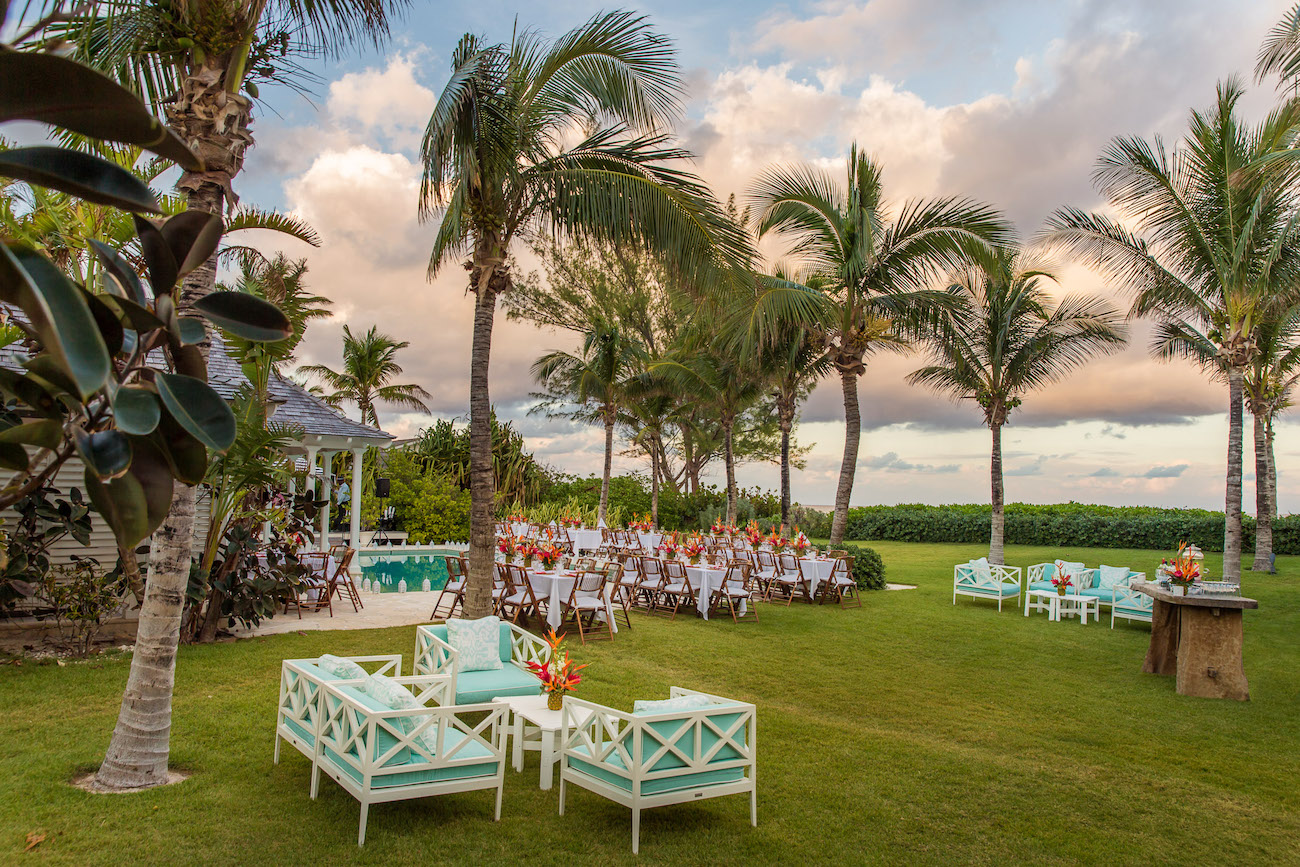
[0,244,111,399]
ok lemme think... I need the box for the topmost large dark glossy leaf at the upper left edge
[0,51,203,172]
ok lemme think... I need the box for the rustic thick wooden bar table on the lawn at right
[1134,581,1260,702]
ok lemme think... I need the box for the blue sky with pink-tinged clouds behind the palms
[226,0,1300,512]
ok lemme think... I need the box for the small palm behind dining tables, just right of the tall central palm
[533,320,645,521]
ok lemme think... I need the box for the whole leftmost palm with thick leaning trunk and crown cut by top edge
[57,0,407,789]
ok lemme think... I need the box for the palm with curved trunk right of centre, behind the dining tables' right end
[749,144,1009,545]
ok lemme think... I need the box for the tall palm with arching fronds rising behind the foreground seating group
[420,12,751,617]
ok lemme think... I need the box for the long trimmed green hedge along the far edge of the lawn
[845,503,1300,554]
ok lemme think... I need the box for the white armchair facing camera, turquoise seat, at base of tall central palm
[415,620,551,705]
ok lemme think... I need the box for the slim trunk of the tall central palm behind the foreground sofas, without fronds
[464,274,497,620]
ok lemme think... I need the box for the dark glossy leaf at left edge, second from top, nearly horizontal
[0,146,161,213]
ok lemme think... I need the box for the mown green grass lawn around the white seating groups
[0,542,1300,864]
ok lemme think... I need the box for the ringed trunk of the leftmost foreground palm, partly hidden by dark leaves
[95,89,240,790]
